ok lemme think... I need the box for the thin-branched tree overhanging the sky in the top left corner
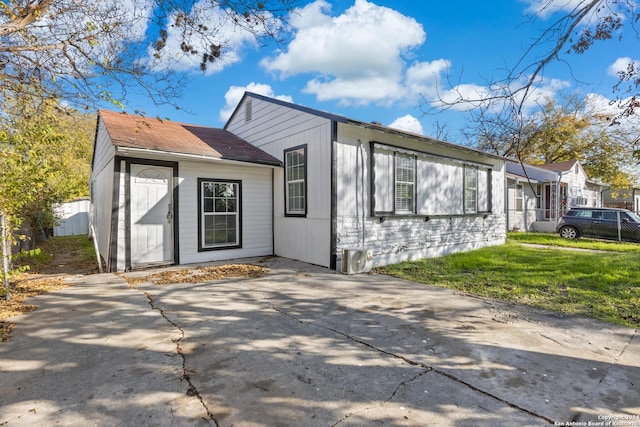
[0,0,296,112]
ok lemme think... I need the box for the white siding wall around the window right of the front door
[178,162,273,264]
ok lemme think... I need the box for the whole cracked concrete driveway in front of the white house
[0,258,640,426]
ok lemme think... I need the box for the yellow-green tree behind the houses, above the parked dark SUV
[466,96,637,188]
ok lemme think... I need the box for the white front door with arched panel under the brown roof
[130,164,173,265]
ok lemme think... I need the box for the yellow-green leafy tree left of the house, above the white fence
[0,100,95,244]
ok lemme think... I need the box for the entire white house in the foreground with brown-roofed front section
[92,93,506,271]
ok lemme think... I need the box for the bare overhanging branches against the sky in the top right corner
[420,0,640,161]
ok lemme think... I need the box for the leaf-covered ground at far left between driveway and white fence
[0,236,99,342]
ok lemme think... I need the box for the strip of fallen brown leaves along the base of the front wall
[121,264,269,287]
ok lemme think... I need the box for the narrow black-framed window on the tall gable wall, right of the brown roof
[284,146,307,216]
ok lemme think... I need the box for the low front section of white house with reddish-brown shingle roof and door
[90,111,280,271]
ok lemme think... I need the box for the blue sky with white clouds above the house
[117,0,640,143]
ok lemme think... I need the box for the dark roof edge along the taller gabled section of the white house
[225,92,507,160]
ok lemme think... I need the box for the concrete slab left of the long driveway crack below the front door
[0,274,209,426]
